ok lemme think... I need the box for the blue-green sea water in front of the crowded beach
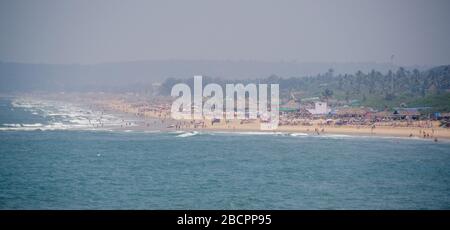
[0,100,450,209]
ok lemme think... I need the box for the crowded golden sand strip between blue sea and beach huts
[88,95,450,140]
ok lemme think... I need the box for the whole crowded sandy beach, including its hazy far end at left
[22,94,450,141]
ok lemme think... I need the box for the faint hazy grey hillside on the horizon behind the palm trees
[0,60,422,92]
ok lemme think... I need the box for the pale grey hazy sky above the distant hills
[0,0,450,65]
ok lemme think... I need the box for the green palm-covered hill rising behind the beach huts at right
[161,65,450,111]
